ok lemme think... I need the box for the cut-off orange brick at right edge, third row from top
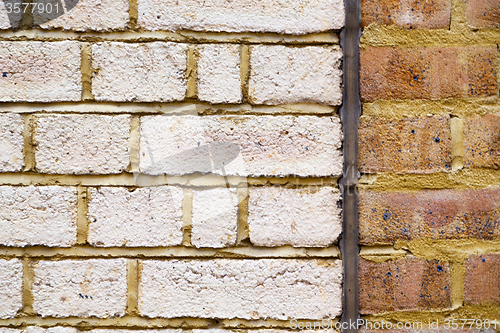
[464,114,500,169]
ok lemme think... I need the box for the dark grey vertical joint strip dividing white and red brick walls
[340,0,361,332]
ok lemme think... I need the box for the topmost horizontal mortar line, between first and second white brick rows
[0,29,339,45]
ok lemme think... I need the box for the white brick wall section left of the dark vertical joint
[0,0,344,333]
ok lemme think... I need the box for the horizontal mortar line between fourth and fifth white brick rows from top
[0,245,340,260]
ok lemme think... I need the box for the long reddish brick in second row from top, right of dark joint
[360,46,498,102]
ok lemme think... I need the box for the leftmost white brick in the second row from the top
[0,42,82,102]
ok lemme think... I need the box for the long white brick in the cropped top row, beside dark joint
[138,0,344,35]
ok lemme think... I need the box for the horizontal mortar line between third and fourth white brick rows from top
[0,172,338,188]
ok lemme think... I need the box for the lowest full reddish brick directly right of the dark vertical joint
[359,257,451,314]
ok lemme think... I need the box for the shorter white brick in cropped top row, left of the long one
[34,0,129,31]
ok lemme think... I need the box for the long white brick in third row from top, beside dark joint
[140,116,343,176]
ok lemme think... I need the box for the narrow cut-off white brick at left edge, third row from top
[0,113,24,172]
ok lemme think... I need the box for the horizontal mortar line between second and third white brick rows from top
[0,102,339,116]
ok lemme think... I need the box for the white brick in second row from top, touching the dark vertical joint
[248,45,342,105]
